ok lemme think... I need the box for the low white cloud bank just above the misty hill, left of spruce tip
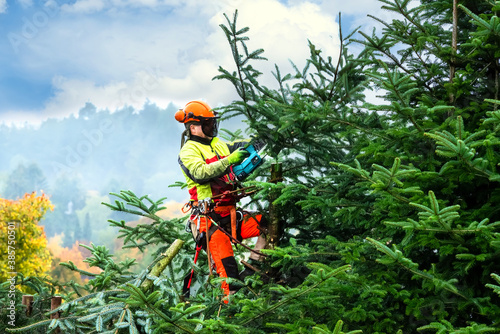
[45,60,235,117]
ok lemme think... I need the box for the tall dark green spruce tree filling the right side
[216,0,500,333]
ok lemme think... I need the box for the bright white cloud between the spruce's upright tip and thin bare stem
[214,0,339,83]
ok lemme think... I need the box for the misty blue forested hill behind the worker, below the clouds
[0,103,204,248]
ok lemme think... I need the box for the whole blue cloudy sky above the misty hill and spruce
[0,0,388,125]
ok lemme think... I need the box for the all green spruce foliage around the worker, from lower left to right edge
[2,0,500,334]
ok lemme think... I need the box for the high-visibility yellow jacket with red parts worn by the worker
[179,136,248,205]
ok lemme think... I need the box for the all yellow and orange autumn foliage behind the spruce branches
[0,192,183,284]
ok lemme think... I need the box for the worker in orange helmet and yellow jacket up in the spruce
[175,101,267,302]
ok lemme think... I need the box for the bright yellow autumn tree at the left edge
[0,192,53,282]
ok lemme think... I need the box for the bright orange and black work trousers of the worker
[193,211,266,296]
